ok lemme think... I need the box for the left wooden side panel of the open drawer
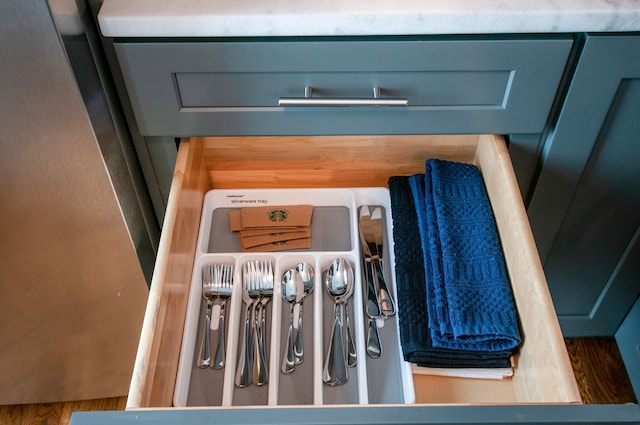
[127,140,208,408]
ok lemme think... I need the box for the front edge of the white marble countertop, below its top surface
[98,0,640,38]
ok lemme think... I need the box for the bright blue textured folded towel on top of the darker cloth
[409,159,521,351]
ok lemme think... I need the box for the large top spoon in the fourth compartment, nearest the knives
[322,258,354,386]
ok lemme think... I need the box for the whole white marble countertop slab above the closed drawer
[98,0,640,37]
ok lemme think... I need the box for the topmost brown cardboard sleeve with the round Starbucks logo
[240,205,313,229]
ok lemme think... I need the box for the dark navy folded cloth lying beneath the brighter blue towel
[389,176,512,368]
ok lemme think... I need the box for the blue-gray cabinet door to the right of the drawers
[528,35,640,336]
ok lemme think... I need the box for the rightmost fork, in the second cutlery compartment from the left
[254,261,273,385]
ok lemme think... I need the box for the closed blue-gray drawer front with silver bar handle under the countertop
[115,36,572,136]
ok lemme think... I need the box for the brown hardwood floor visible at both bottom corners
[0,338,637,425]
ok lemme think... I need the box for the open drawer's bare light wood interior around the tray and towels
[127,135,581,409]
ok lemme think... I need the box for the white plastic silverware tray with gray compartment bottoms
[174,188,415,407]
